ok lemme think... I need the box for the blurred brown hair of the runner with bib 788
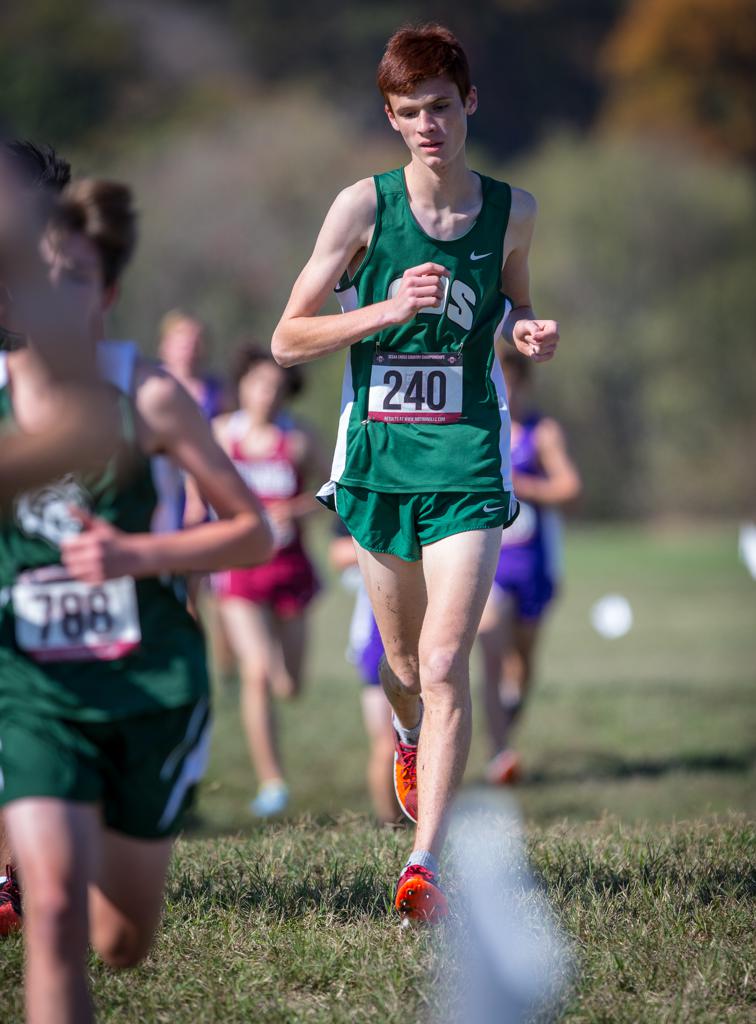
[52,178,137,288]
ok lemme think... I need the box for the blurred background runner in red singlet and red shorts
[207,345,325,818]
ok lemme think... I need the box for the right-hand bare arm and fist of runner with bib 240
[501,188,559,362]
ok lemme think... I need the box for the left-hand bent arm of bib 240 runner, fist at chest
[271,178,447,367]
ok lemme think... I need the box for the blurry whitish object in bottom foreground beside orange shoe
[437,791,572,1024]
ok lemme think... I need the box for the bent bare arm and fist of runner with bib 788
[60,370,272,583]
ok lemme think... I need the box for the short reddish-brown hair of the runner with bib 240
[377,22,472,102]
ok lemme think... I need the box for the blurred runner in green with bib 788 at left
[0,181,270,1024]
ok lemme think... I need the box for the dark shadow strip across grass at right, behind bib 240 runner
[521,748,756,787]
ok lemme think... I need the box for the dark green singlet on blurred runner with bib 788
[0,354,208,722]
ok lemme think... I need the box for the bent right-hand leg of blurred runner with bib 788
[89,829,173,968]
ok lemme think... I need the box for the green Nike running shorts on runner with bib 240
[336,484,518,562]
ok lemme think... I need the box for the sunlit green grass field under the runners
[0,527,756,1024]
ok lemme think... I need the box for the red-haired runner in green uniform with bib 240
[274,26,558,920]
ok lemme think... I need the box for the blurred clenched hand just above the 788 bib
[60,508,143,584]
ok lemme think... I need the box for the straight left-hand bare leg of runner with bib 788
[4,797,101,1024]
